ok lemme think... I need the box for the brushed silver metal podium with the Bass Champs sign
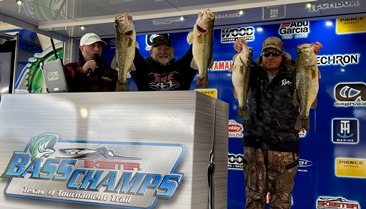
[0,91,228,209]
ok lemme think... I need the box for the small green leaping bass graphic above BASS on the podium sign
[29,134,58,161]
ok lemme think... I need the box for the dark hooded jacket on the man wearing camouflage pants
[243,56,299,152]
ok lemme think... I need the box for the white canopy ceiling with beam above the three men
[0,0,366,39]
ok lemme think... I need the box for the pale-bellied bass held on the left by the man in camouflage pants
[230,40,253,120]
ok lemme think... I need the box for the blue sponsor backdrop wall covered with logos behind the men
[103,17,366,209]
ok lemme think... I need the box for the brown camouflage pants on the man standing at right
[243,147,299,209]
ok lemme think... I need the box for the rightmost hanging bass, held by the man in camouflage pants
[293,44,321,131]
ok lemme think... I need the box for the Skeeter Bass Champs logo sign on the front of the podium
[2,133,183,208]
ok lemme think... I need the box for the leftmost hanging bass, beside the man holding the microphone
[111,13,137,91]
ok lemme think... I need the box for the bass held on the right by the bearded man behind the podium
[188,9,215,88]
